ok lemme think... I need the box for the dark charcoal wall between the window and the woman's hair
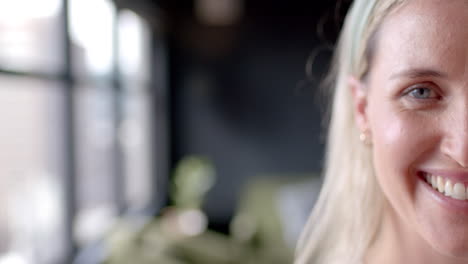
[141,1,349,230]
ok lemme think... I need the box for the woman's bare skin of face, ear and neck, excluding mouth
[349,0,468,264]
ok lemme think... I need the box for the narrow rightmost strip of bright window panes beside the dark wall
[118,10,154,211]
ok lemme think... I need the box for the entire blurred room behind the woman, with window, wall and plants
[0,0,350,264]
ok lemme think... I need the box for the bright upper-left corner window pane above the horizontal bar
[0,0,64,74]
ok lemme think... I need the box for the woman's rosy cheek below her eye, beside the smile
[369,104,434,207]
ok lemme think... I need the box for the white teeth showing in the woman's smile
[424,173,468,200]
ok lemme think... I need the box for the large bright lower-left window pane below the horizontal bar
[0,75,65,263]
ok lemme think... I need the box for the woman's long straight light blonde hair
[295,0,404,264]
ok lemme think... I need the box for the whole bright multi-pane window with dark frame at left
[0,0,159,264]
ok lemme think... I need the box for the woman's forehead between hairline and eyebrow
[371,0,468,80]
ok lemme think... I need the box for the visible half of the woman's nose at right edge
[441,105,468,168]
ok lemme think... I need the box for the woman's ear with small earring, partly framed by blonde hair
[348,76,369,132]
